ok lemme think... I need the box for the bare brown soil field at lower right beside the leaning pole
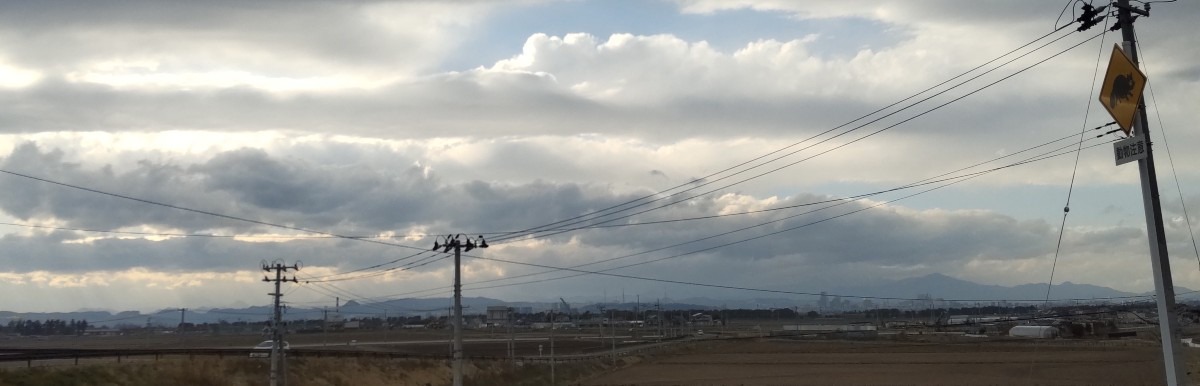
[583,339,1200,386]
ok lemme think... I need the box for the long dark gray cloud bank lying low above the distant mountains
[0,140,1138,276]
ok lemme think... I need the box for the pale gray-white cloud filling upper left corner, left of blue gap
[0,1,488,90]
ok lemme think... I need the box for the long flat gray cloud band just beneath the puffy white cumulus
[0,73,869,139]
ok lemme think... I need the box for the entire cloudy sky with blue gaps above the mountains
[0,0,1200,312]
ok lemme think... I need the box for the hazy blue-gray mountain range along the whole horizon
[0,273,1180,327]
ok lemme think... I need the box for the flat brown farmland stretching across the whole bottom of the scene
[11,331,1200,386]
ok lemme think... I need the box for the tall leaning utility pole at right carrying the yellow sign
[1114,0,1187,386]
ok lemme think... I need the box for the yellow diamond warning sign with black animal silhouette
[1099,44,1146,135]
